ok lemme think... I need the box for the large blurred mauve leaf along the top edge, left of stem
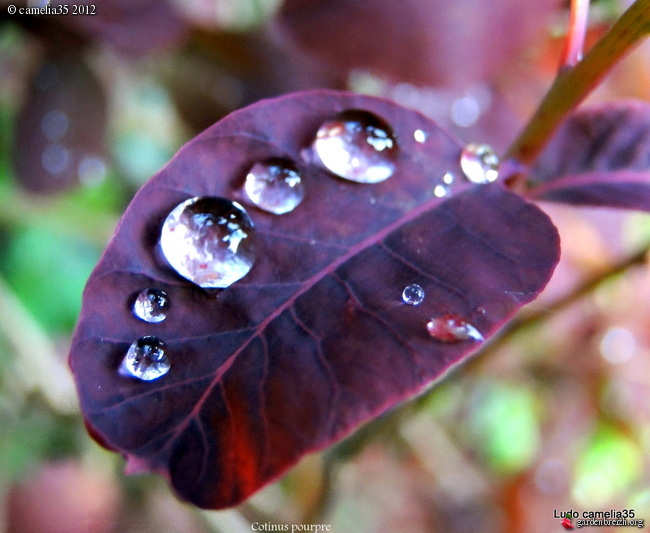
[276,0,561,87]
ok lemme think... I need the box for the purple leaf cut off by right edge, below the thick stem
[531,101,650,211]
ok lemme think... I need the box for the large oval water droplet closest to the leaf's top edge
[313,110,397,183]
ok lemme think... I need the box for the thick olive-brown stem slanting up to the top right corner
[505,0,650,165]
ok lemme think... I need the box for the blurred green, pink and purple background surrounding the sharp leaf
[0,0,650,533]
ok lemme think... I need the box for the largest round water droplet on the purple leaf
[160,197,255,289]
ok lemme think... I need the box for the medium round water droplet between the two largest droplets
[244,158,305,215]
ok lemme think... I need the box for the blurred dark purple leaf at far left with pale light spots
[14,54,107,193]
